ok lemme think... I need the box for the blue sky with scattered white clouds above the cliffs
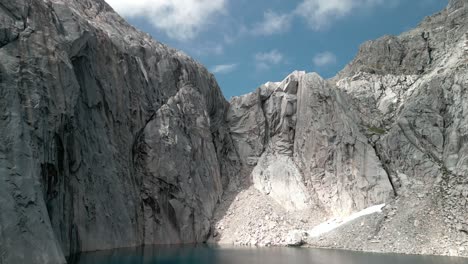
[106,0,447,99]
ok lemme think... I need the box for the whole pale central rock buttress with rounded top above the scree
[228,69,393,216]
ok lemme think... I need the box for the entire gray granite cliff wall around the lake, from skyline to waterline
[0,0,468,264]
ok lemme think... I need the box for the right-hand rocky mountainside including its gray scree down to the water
[320,0,468,256]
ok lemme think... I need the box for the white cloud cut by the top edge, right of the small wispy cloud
[294,0,388,30]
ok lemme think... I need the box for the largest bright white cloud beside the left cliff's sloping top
[106,0,228,41]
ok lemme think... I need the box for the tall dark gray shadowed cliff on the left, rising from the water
[0,0,238,263]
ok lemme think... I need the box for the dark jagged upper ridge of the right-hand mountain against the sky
[334,0,468,80]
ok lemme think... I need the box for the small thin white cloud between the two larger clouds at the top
[252,10,291,35]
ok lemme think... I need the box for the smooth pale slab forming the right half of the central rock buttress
[294,74,393,216]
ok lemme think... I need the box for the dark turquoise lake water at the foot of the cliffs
[70,246,468,264]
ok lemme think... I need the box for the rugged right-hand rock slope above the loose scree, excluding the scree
[336,1,468,198]
